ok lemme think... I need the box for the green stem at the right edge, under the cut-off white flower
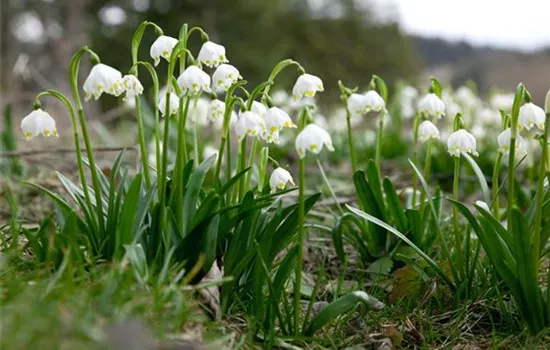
[531,113,550,258]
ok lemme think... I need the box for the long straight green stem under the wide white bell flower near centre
[294,158,306,334]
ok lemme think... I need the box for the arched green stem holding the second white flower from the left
[69,46,105,231]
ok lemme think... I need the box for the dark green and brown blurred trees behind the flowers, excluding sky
[0,0,420,111]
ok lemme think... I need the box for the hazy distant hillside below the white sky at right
[411,36,550,103]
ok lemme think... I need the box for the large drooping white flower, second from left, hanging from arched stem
[83,63,124,101]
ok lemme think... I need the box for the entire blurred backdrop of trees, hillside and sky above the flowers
[0,0,550,119]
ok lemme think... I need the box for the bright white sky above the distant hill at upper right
[367,0,550,51]
